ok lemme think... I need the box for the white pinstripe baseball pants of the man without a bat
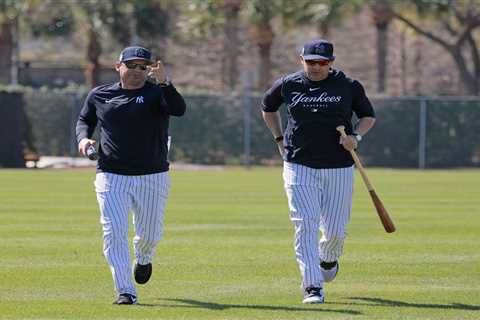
[95,171,170,296]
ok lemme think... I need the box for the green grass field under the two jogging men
[0,168,480,320]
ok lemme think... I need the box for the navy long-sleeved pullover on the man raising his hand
[76,82,186,175]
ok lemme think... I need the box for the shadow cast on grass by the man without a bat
[138,299,362,315]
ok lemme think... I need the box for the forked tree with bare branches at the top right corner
[390,0,480,95]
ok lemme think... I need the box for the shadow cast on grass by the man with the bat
[333,297,480,311]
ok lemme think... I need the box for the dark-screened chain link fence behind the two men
[17,90,480,168]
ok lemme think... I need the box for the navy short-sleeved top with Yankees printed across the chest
[262,69,375,169]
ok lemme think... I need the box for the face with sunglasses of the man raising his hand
[115,59,149,89]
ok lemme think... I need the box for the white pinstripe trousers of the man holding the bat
[283,162,354,289]
